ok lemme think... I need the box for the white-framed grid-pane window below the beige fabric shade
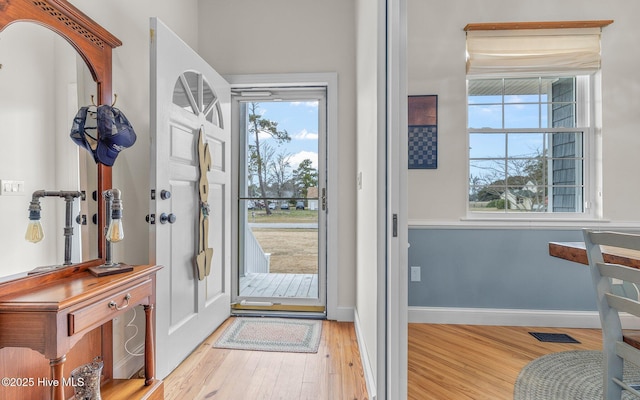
[467,76,590,213]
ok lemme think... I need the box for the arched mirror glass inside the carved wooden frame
[0,22,98,276]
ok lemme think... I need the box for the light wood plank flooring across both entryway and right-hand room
[164,321,601,400]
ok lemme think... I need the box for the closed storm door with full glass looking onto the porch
[233,87,327,313]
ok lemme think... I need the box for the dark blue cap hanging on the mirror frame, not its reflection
[95,105,136,166]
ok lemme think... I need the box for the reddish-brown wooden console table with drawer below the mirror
[0,265,164,400]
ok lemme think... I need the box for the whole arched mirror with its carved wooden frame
[0,0,121,284]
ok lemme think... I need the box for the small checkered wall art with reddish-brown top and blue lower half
[408,95,438,169]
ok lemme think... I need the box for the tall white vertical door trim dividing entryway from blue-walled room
[378,0,409,400]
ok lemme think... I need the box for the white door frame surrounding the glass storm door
[224,73,342,321]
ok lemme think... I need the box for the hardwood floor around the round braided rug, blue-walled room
[408,324,602,400]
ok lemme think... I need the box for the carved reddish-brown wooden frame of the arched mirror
[0,0,122,292]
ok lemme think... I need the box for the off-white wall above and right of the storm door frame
[199,0,356,309]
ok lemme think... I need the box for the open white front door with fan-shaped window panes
[150,18,231,379]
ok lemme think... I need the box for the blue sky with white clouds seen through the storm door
[250,101,318,169]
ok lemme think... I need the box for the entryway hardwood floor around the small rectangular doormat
[164,318,368,400]
